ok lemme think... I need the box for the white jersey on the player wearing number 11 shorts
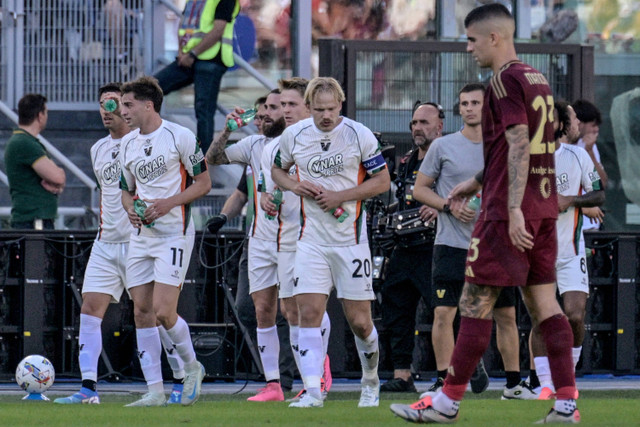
[120,120,207,237]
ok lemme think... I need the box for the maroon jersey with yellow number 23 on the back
[482,61,558,221]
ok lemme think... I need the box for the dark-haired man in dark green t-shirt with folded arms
[4,94,66,230]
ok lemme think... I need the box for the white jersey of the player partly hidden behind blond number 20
[261,137,300,252]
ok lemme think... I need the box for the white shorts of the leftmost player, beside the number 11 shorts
[82,240,129,303]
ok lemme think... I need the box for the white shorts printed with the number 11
[127,234,194,289]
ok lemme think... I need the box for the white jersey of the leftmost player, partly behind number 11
[91,135,134,243]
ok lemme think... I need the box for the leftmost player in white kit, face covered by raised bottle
[54,83,133,404]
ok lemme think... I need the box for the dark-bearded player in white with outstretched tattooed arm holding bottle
[206,89,286,402]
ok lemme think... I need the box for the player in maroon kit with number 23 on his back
[391,3,580,424]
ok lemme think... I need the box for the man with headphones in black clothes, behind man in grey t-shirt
[380,101,444,392]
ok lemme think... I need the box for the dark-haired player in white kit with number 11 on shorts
[120,77,211,406]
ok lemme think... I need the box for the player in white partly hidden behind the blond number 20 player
[260,77,332,402]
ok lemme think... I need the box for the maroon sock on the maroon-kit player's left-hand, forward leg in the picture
[442,317,493,401]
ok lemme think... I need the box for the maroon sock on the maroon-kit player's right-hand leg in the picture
[540,314,576,400]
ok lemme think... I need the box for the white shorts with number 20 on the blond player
[293,241,375,301]
